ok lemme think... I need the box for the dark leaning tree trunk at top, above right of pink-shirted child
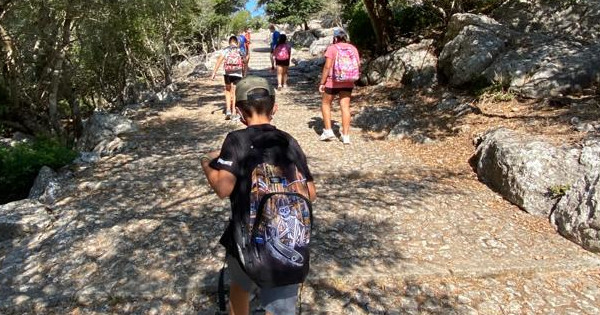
[363,0,392,53]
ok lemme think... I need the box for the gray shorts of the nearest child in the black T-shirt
[227,255,298,315]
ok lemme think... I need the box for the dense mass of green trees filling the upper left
[0,0,250,140]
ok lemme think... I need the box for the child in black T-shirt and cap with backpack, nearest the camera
[200,76,316,315]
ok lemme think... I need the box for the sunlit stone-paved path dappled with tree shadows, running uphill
[0,30,600,314]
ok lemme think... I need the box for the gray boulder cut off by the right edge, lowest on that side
[550,169,600,253]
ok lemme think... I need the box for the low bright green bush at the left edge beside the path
[0,138,77,204]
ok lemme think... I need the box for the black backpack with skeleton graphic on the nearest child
[233,137,313,287]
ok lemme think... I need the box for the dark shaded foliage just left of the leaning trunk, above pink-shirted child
[343,2,375,50]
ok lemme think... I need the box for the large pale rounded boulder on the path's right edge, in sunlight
[471,128,584,216]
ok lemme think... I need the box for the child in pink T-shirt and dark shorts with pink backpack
[319,29,360,144]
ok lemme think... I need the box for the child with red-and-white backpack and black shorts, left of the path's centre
[211,36,244,120]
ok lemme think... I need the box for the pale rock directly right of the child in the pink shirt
[362,39,437,86]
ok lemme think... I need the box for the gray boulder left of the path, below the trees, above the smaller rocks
[77,112,137,155]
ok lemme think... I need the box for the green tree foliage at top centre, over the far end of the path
[259,0,323,25]
